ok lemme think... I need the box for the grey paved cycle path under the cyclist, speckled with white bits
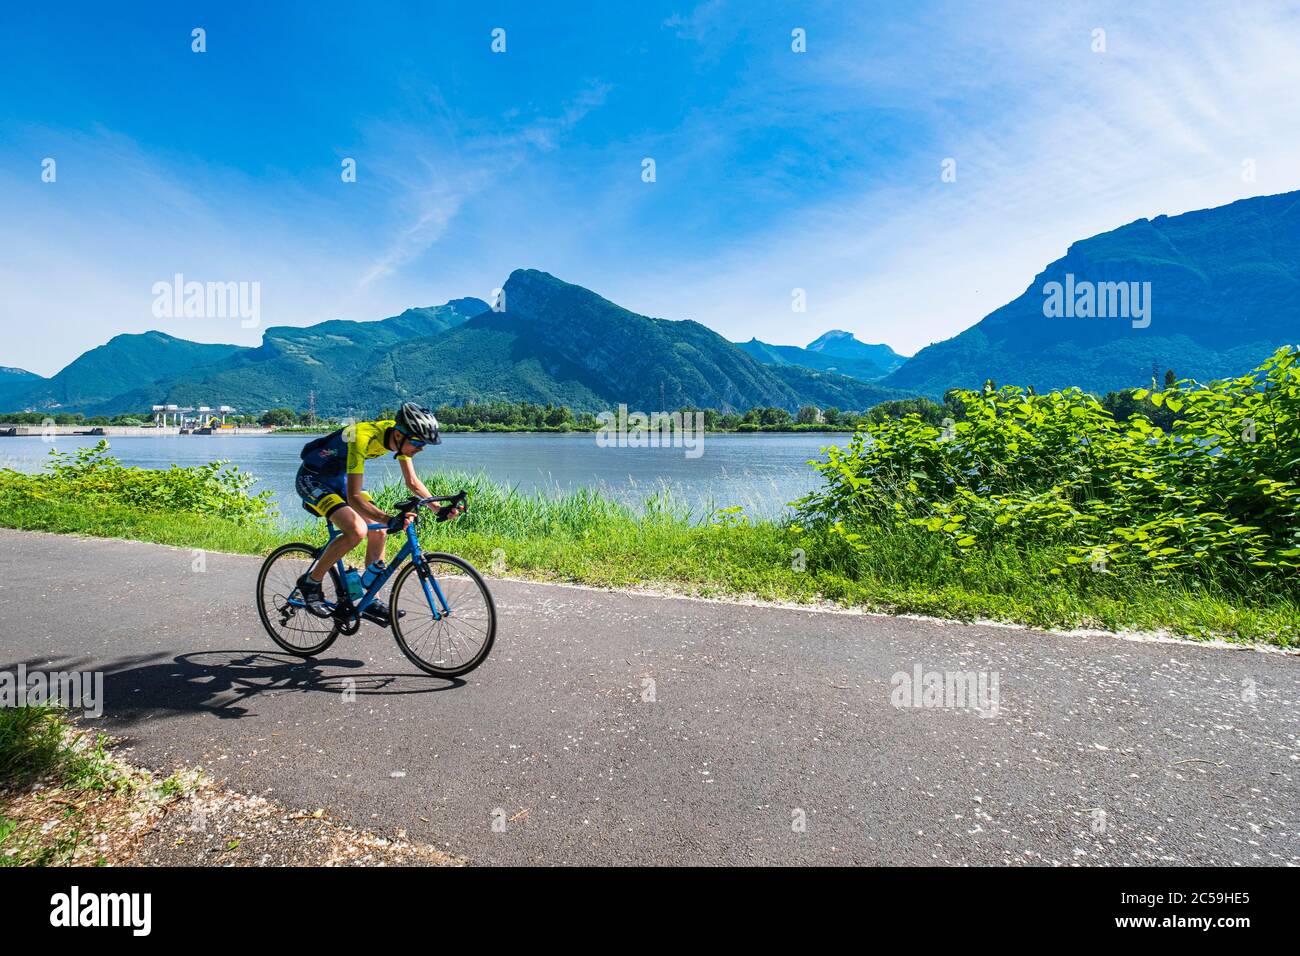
[0,531,1300,865]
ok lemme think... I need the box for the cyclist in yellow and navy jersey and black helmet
[294,402,460,627]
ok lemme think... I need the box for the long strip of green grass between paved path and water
[0,472,1300,648]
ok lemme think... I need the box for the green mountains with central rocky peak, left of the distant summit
[0,269,900,416]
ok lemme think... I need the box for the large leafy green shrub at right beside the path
[798,349,1300,581]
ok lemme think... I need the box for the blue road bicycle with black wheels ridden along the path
[257,492,497,678]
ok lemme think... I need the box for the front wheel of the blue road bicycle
[391,553,497,678]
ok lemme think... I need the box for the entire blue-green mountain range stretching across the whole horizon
[0,193,1300,415]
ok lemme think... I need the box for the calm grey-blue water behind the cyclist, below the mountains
[0,433,849,520]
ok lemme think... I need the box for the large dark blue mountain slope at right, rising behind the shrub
[880,191,1300,397]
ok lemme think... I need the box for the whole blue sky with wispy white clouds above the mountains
[0,0,1300,375]
